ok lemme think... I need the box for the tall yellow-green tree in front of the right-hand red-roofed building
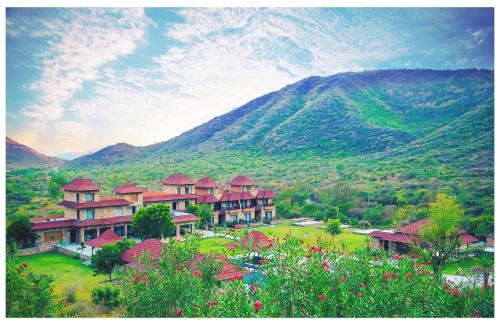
[420,193,464,272]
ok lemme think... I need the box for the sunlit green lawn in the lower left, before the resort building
[20,253,107,302]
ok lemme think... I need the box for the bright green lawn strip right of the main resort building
[248,224,370,253]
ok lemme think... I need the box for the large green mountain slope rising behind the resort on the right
[67,69,494,209]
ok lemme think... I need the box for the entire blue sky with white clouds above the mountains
[6,8,493,157]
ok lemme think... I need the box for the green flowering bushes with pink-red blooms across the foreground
[121,234,494,317]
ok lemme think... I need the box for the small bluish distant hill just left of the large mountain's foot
[71,143,141,167]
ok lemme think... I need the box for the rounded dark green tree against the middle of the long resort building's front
[132,204,175,239]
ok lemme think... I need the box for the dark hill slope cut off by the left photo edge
[6,137,64,169]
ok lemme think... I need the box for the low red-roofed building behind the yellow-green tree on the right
[370,218,479,253]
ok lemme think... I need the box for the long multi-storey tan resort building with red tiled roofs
[32,174,276,246]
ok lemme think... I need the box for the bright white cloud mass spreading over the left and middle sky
[12,9,406,153]
